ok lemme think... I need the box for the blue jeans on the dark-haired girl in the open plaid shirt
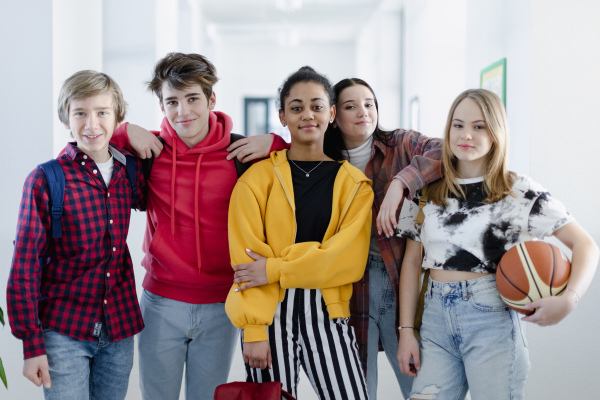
[367,255,413,400]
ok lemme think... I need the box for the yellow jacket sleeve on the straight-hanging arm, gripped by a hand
[225,182,279,342]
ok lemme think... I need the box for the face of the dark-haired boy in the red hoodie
[160,82,216,148]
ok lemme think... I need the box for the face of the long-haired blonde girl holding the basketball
[449,97,493,178]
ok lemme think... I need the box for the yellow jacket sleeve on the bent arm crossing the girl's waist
[267,182,373,289]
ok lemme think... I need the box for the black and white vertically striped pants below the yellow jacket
[242,289,368,400]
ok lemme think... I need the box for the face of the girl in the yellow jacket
[279,81,335,151]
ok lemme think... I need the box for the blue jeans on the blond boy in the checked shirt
[44,327,133,400]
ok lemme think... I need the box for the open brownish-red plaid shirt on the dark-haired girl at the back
[350,129,442,374]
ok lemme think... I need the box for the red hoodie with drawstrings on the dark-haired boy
[113,112,285,304]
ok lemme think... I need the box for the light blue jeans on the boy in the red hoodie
[138,290,238,400]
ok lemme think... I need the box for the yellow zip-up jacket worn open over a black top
[225,150,373,342]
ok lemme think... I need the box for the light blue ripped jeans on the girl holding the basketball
[411,275,529,400]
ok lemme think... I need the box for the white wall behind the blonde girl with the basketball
[404,0,600,400]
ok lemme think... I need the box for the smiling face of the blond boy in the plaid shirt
[66,93,116,163]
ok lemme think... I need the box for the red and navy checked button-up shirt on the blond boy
[7,144,145,359]
